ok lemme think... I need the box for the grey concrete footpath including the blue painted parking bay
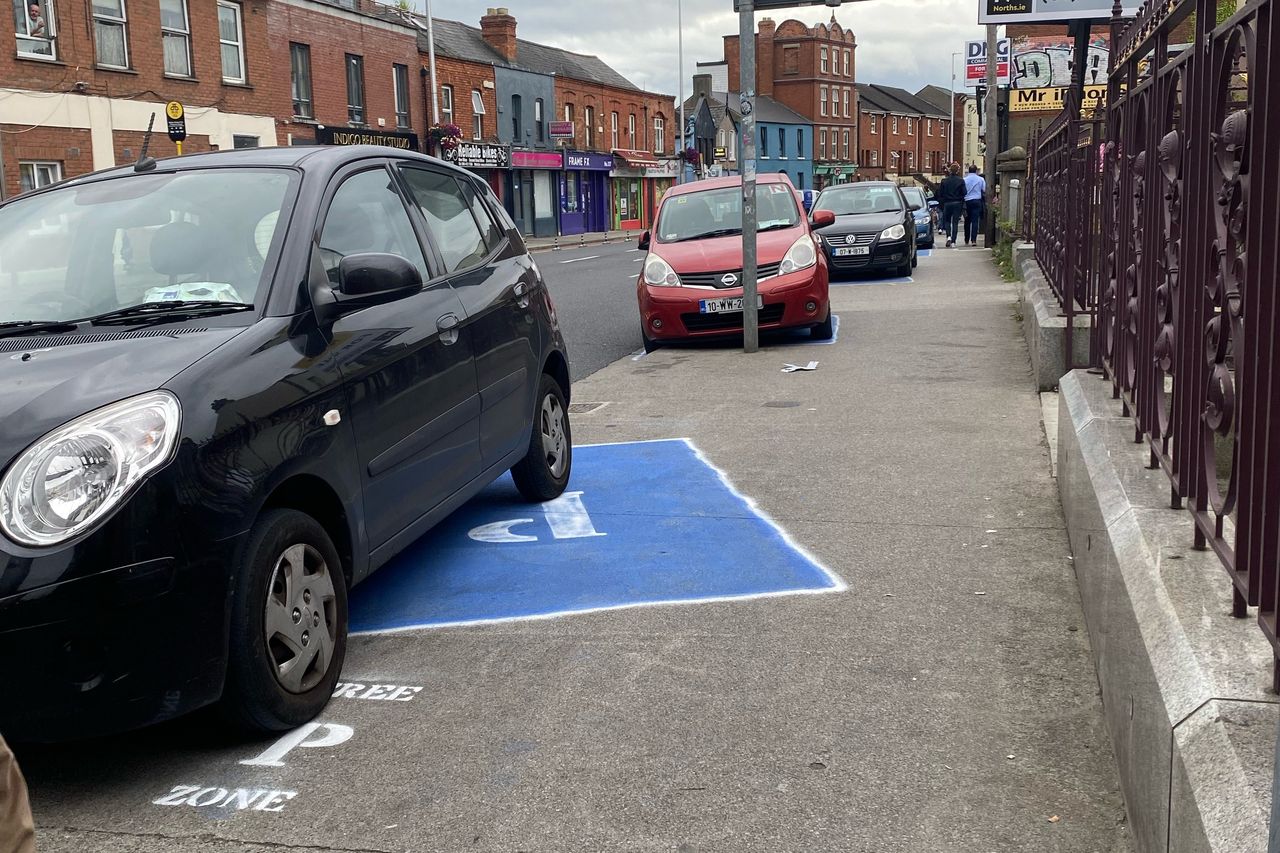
[19,250,1130,853]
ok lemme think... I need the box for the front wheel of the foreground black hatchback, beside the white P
[220,508,347,731]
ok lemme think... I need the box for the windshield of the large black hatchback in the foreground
[0,169,294,323]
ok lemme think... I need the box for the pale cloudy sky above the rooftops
[411,0,984,95]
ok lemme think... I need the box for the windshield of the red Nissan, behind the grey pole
[657,183,800,243]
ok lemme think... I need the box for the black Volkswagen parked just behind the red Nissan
[812,181,916,278]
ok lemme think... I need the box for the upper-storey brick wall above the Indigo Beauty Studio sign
[268,3,422,143]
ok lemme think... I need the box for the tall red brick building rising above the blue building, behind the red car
[724,14,858,188]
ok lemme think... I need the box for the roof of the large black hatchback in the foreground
[37,145,471,192]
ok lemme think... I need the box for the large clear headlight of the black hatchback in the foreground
[0,391,180,547]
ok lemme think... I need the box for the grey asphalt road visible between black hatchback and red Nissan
[534,242,644,382]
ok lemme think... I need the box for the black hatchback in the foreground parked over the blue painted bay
[0,147,572,740]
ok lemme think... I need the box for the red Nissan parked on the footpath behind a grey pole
[636,174,832,351]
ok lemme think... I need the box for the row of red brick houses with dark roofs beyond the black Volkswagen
[858,83,952,179]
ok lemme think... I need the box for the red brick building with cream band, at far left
[0,0,279,195]
